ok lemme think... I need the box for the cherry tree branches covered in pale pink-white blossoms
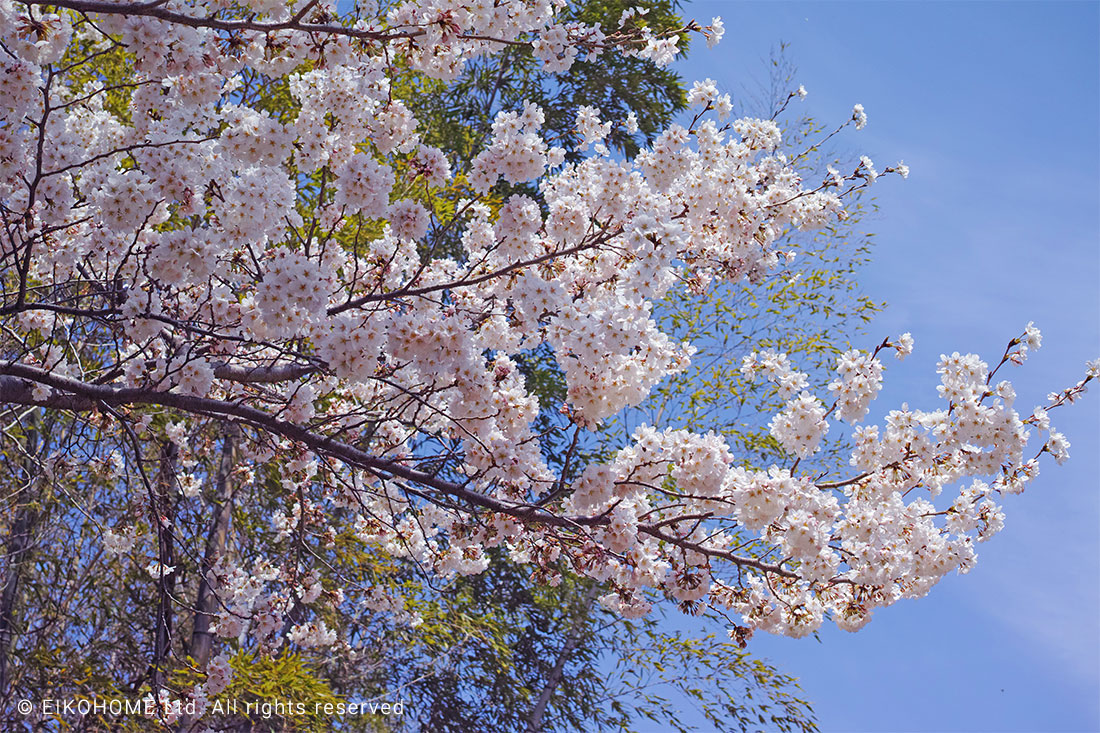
[0,0,1100,723]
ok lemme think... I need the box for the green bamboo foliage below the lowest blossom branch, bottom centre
[343,554,816,733]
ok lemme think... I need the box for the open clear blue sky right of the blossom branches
[679,0,1100,731]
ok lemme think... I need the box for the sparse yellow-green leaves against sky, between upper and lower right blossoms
[601,50,884,470]
